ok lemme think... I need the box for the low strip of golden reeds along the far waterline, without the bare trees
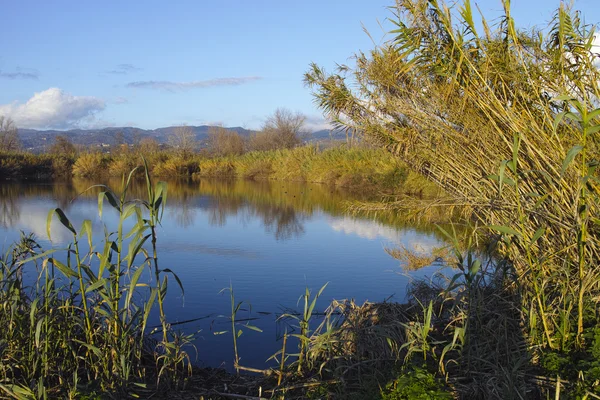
[0,145,441,198]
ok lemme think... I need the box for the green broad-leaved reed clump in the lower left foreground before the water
[0,159,190,399]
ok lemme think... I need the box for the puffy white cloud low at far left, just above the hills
[0,88,105,129]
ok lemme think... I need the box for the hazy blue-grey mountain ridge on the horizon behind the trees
[19,125,345,153]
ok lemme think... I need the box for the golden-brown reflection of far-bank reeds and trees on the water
[0,179,452,240]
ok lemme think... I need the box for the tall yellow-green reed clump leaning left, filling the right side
[305,0,600,398]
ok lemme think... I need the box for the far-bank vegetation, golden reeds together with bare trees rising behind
[0,109,438,197]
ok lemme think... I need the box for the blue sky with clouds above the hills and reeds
[0,0,600,129]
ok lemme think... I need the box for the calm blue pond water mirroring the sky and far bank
[0,180,441,368]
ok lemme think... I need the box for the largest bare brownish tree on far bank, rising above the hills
[250,108,306,150]
